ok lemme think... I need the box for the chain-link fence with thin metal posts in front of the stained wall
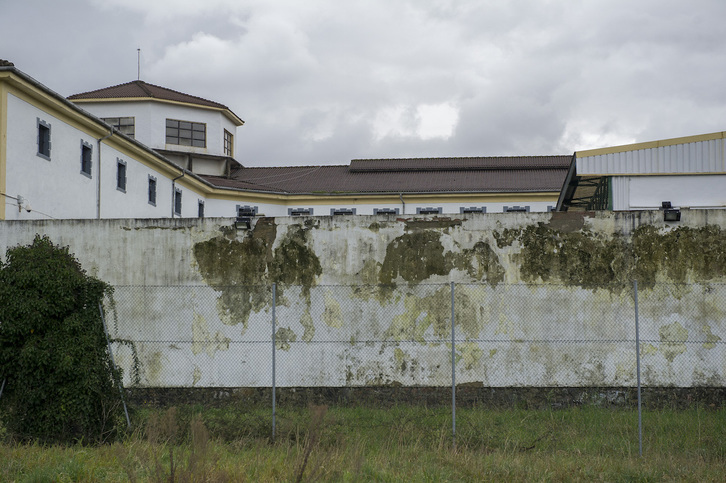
[104,284,726,450]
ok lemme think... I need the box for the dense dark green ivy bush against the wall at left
[0,235,123,443]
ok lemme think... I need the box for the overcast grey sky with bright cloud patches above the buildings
[0,0,726,166]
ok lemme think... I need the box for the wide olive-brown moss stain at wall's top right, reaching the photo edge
[493,223,726,292]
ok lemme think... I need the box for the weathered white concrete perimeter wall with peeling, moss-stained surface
[0,210,726,387]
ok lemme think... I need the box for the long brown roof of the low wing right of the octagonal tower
[202,156,572,195]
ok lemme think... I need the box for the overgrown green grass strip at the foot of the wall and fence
[0,406,726,482]
